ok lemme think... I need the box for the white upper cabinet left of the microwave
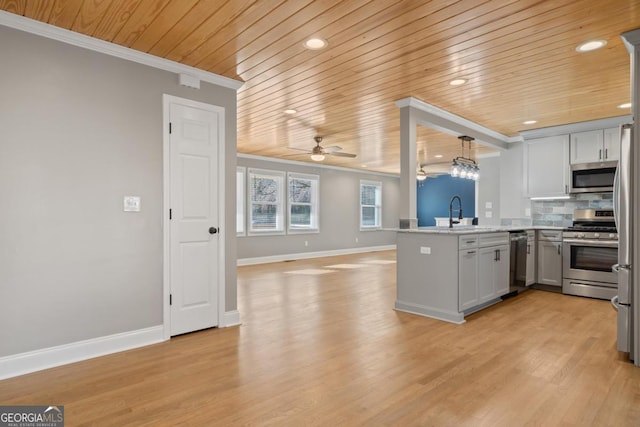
[525,135,569,197]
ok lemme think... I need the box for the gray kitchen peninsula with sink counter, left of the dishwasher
[395,226,509,323]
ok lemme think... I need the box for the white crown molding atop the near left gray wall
[0,11,244,91]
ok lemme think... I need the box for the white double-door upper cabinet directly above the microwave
[570,128,620,165]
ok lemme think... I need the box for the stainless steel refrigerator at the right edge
[611,125,638,360]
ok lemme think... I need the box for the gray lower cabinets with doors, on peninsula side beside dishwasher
[458,233,509,311]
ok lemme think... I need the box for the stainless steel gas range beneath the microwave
[562,209,618,300]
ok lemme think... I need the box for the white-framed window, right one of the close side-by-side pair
[288,173,319,232]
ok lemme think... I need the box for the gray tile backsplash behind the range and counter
[531,193,613,227]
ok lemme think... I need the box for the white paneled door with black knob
[169,101,224,335]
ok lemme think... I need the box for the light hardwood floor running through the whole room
[0,251,640,426]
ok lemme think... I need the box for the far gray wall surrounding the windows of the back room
[237,156,400,259]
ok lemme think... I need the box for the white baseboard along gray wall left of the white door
[0,325,164,380]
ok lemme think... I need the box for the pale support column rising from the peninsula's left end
[399,106,418,229]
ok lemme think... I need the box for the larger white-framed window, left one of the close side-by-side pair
[249,169,284,234]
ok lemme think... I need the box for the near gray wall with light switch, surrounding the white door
[0,26,236,357]
